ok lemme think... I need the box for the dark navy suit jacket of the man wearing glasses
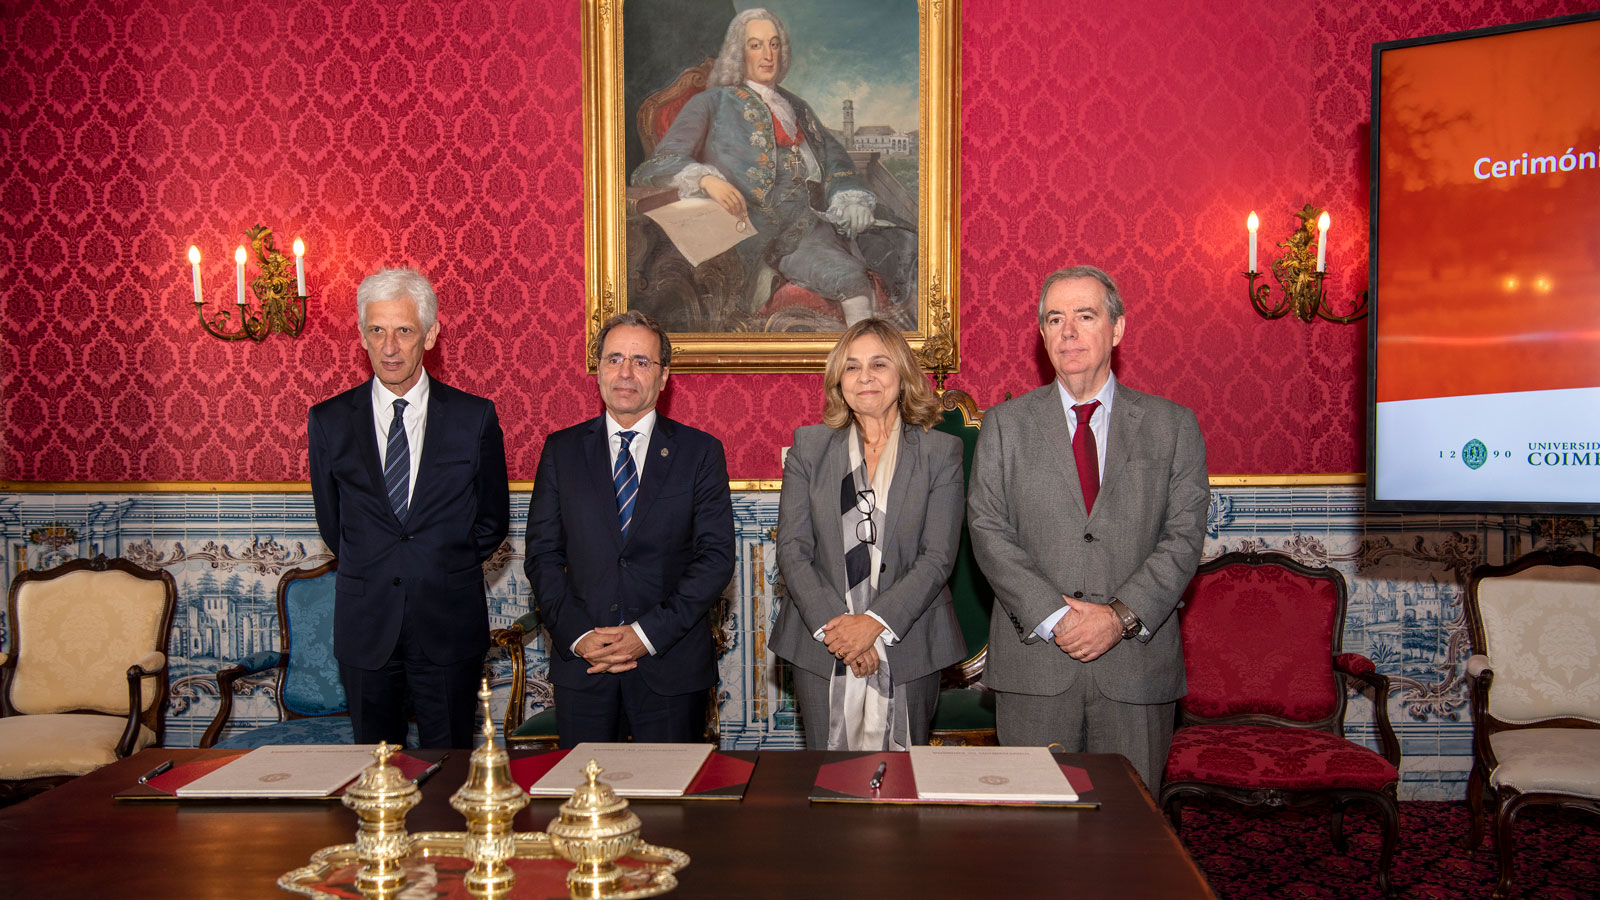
[525,413,733,697]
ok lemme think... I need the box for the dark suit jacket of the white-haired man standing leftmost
[307,378,510,669]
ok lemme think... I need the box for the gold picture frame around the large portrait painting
[581,0,960,373]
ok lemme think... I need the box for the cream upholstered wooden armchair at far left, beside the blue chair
[0,556,178,796]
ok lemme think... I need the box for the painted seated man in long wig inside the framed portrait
[634,10,915,323]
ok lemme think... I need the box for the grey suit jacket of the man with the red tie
[966,381,1211,703]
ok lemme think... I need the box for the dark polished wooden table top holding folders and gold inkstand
[0,749,1214,900]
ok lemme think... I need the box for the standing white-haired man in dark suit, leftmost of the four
[307,269,510,748]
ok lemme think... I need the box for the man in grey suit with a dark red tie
[966,266,1210,793]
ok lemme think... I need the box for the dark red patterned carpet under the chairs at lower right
[1181,802,1600,900]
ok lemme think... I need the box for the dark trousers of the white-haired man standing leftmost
[339,634,483,749]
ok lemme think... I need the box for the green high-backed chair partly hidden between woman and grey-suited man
[928,389,997,746]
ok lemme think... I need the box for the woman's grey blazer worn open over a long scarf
[770,424,966,684]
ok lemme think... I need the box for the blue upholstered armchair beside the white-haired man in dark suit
[200,560,354,748]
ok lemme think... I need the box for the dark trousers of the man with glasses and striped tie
[555,669,706,748]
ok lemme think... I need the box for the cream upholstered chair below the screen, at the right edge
[1466,551,1600,900]
